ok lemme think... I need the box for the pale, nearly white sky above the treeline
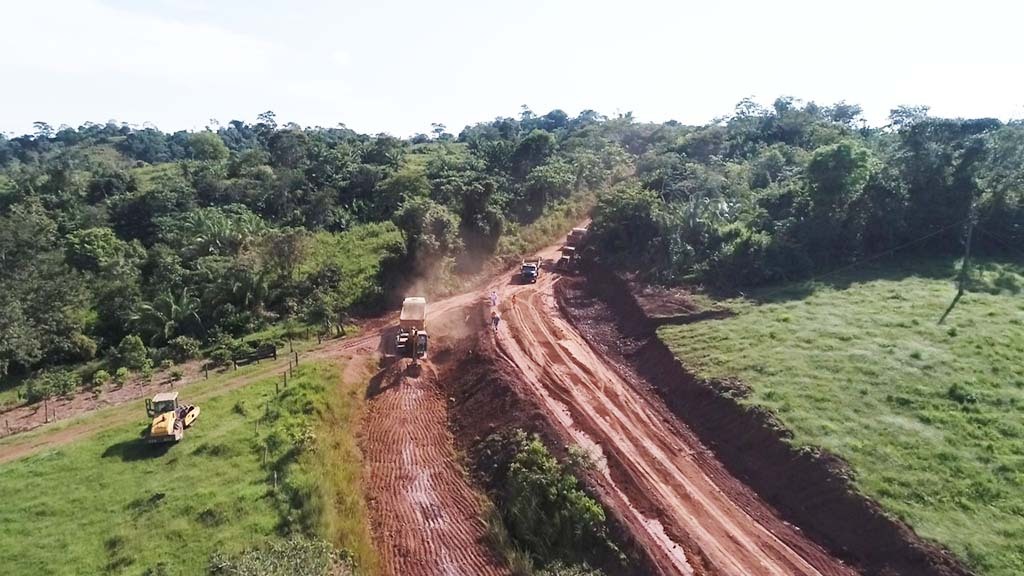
[0,0,1024,136]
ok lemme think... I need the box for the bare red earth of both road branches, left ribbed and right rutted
[352,237,855,576]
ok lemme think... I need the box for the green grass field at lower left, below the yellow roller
[0,363,373,575]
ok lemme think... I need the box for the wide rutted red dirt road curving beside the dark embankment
[496,242,854,576]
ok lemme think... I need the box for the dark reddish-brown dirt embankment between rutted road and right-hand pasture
[573,270,970,576]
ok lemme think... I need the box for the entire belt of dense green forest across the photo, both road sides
[0,98,1024,388]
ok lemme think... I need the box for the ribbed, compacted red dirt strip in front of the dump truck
[359,360,507,576]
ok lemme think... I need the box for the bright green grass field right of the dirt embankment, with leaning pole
[658,261,1024,576]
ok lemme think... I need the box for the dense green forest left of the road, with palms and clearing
[0,107,632,385]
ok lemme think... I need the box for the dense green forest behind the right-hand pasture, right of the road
[592,98,1024,290]
